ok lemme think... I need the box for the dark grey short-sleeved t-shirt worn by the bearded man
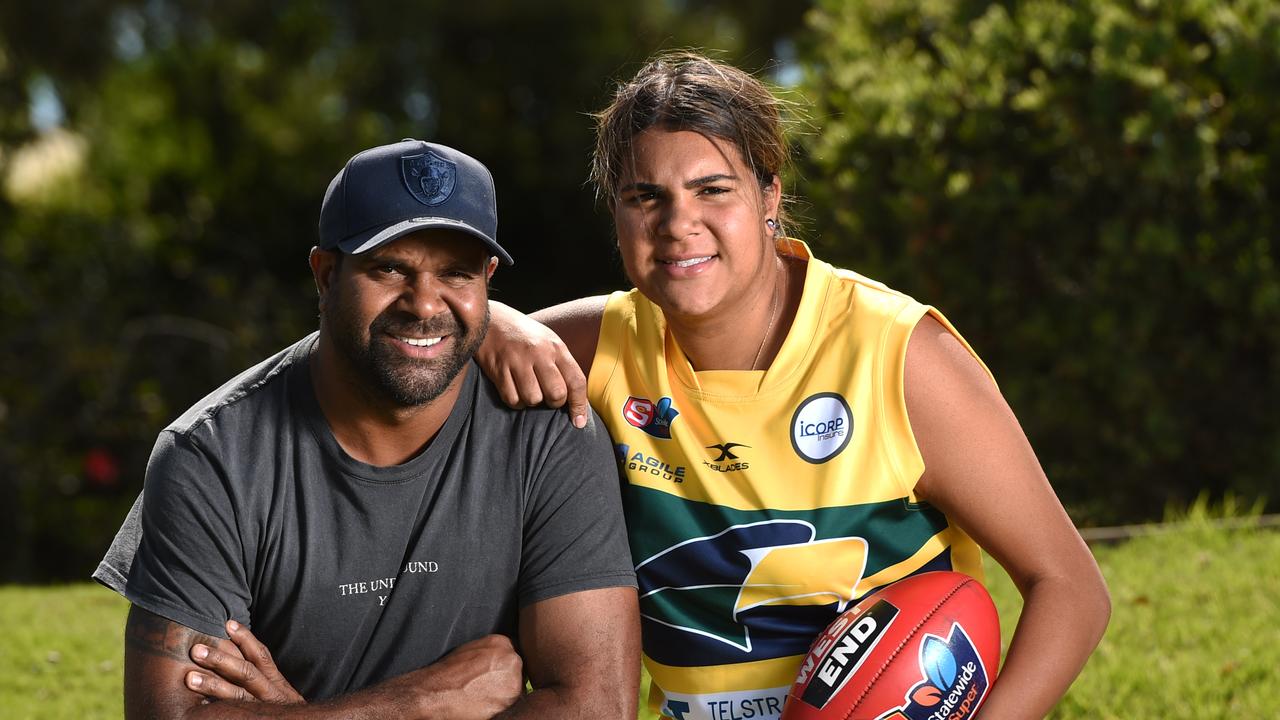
[93,336,634,700]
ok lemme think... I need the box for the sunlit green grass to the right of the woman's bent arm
[1039,506,1280,720]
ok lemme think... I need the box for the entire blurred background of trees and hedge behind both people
[0,0,1280,580]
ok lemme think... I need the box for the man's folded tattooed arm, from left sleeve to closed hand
[124,606,524,720]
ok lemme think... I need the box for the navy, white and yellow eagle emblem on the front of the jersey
[636,519,867,666]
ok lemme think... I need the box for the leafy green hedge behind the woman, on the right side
[801,0,1280,523]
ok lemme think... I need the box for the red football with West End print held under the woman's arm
[782,571,1000,720]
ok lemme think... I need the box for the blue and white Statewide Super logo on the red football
[878,623,991,720]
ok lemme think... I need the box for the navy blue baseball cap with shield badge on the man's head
[320,140,515,265]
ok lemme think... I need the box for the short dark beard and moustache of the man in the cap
[326,299,489,407]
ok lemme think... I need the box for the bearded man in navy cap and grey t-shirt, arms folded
[95,141,639,717]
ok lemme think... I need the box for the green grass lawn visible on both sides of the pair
[0,512,1280,720]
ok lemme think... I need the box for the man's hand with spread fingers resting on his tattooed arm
[186,620,306,705]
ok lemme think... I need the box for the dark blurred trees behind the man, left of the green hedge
[0,0,805,580]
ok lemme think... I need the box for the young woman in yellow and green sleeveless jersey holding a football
[479,53,1110,720]
